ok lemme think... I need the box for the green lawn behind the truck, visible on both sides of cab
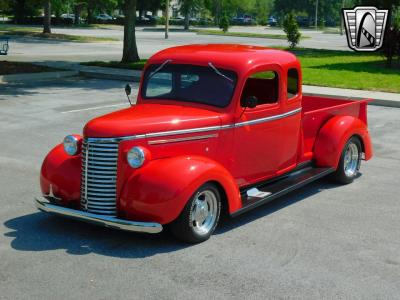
[85,48,400,93]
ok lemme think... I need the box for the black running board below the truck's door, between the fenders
[231,167,335,217]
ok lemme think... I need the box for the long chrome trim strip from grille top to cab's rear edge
[87,107,301,143]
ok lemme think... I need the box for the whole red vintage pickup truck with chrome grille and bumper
[35,45,372,243]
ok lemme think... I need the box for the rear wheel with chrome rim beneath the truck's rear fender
[331,136,362,184]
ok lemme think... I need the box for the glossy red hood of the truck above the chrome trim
[83,104,221,138]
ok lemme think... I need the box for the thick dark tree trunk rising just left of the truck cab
[121,0,139,63]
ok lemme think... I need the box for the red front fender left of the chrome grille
[40,144,81,205]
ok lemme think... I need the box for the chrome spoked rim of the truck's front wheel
[190,190,218,235]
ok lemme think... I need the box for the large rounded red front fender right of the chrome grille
[119,156,241,224]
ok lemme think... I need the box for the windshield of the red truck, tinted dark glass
[142,63,237,107]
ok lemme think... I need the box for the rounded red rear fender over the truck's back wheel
[314,116,372,169]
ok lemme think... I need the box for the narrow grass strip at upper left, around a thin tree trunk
[0,25,118,43]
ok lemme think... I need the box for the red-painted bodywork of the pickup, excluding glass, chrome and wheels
[40,45,372,224]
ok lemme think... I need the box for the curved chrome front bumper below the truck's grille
[35,197,163,233]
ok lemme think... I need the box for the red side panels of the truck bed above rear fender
[302,95,369,160]
